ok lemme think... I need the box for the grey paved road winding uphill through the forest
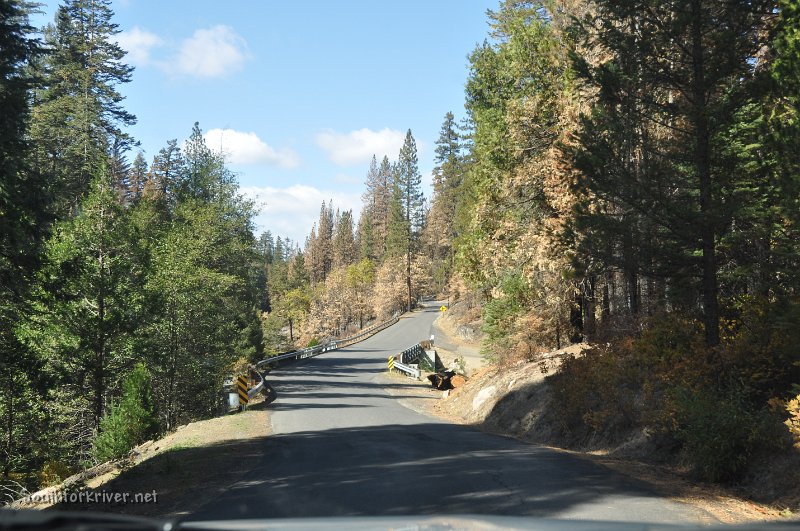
[184,306,708,523]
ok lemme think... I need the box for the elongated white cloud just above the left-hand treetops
[204,129,300,168]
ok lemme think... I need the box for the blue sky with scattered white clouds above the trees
[35,0,498,242]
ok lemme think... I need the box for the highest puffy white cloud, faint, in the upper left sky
[173,25,247,78]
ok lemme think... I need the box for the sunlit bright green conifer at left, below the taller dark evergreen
[30,176,142,464]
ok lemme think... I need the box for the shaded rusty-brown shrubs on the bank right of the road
[550,298,800,481]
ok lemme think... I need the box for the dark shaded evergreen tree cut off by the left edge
[0,0,50,487]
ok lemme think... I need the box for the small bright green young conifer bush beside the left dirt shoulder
[94,363,158,462]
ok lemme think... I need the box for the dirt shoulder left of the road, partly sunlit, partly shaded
[12,398,269,518]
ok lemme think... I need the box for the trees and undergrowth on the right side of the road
[444,0,800,490]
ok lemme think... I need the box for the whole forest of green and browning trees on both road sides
[0,0,800,499]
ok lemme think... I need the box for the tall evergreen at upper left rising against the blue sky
[31,0,136,214]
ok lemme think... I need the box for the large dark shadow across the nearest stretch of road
[180,423,688,520]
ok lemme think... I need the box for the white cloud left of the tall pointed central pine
[316,127,406,166]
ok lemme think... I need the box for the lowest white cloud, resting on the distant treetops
[240,184,361,246]
